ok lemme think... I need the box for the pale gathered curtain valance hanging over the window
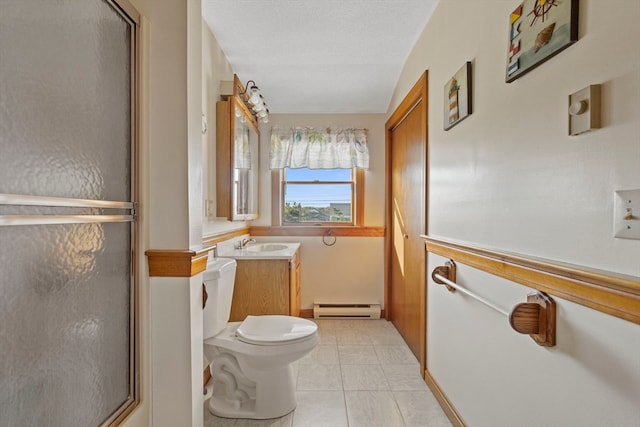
[269,126,369,169]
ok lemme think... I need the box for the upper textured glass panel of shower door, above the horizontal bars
[0,0,131,200]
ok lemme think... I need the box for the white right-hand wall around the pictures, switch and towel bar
[389,0,640,427]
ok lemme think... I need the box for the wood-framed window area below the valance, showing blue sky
[274,168,364,226]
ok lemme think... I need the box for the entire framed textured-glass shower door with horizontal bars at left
[0,0,137,427]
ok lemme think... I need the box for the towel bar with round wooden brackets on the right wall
[431,260,556,347]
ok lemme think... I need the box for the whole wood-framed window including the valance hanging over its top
[269,126,369,227]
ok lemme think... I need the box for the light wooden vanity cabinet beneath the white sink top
[229,252,300,322]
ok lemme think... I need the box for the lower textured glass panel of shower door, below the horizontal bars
[0,224,131,427]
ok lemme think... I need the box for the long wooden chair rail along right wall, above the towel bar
[422,236,640,324]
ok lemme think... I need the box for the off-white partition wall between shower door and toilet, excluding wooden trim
[123,0,208,427]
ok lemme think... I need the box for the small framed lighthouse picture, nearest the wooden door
[444,62,471,130]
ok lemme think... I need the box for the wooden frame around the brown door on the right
[384,70,429,378]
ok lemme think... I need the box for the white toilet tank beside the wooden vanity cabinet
[203,258,236,339]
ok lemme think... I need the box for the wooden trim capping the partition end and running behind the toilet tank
[145,227,249,277]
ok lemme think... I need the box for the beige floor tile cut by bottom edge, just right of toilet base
[293,391,348,427]
